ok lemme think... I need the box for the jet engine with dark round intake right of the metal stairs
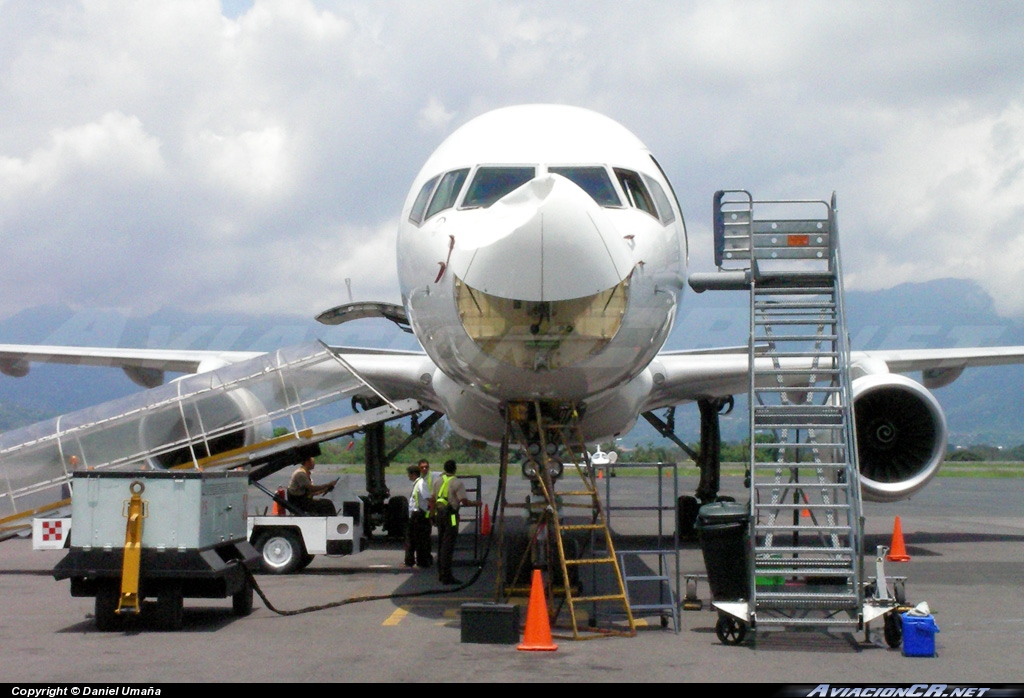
[853,374,948,501]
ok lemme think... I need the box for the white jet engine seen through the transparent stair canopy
[138,388,271,468]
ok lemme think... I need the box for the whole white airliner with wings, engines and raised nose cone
[0,104,1024,521]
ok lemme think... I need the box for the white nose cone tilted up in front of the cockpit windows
[445,174,633,301]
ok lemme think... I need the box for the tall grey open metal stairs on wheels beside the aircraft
[690,190,882,644]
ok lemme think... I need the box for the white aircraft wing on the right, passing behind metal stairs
[643,346,1024,411]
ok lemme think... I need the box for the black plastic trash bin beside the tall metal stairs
[697,501,751,601]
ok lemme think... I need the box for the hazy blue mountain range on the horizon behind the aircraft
[0,278,1024,446]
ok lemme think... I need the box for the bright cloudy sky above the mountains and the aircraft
[0,0,1024,316]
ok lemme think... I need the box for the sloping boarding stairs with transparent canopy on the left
[0,342,423,538]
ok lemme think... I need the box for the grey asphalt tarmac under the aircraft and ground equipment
[0,474,1024,686]
